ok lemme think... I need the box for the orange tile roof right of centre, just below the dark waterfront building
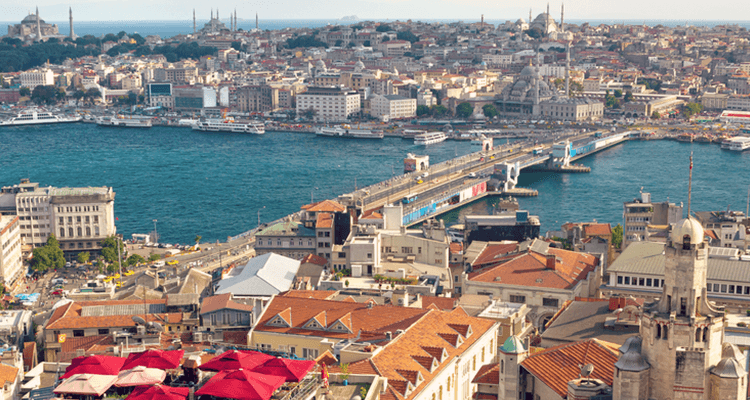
[469,248,599,289]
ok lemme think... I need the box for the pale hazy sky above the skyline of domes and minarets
[0,0,750,22]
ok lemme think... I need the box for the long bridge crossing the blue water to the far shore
[338,131,631,226]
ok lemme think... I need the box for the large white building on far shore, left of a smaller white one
[297,86,361,121]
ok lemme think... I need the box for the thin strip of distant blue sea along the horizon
[0,17,750,38]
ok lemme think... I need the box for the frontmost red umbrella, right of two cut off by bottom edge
[195,369,285,400]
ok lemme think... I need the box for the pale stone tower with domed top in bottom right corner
[613,217,747,400]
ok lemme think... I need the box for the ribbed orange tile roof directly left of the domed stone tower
[521,339,620,397]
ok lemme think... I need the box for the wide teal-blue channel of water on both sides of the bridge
[0,124,750,243]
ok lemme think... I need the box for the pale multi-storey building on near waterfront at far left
[0,180,116,258]
